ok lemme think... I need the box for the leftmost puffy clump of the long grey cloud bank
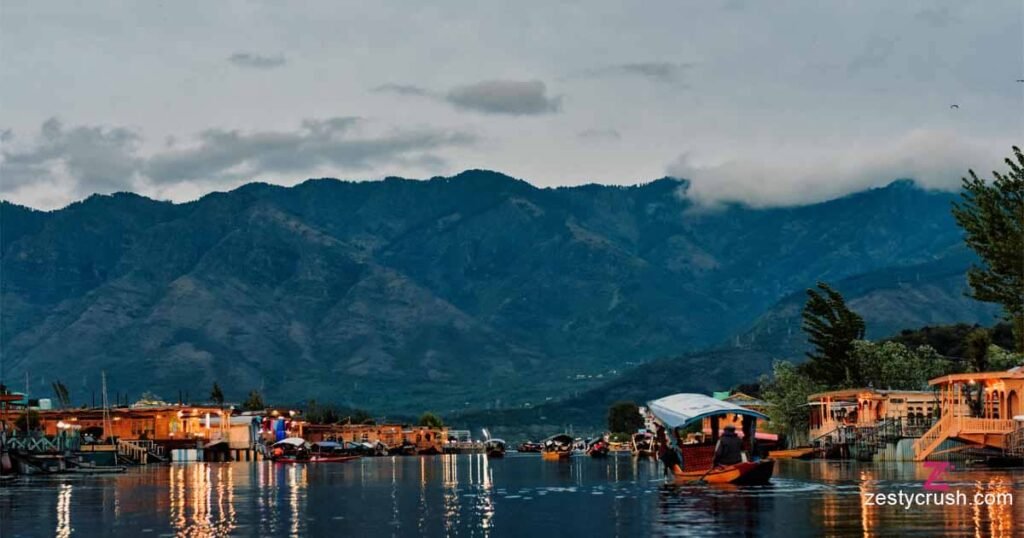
[0,118,140,193]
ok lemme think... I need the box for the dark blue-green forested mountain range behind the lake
[0,170,992,413]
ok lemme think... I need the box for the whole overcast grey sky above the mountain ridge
[0,0,1024,208]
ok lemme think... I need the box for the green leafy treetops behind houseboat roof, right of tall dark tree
[852,340,953,390]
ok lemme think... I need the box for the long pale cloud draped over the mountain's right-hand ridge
[668,130,1010,207]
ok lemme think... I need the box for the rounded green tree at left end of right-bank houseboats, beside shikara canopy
[761,361,825,432]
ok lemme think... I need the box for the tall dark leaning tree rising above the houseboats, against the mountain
[803,282,864,387]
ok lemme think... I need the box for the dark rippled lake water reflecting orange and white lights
[0,454,1024,538]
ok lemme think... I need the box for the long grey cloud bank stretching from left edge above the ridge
[0,117,475,204]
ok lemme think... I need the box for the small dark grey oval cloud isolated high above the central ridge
[444,80,562,116]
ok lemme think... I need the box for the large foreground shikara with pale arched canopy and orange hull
[647,394,775,485]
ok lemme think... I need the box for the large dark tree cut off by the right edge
[952,146,1024,351]
